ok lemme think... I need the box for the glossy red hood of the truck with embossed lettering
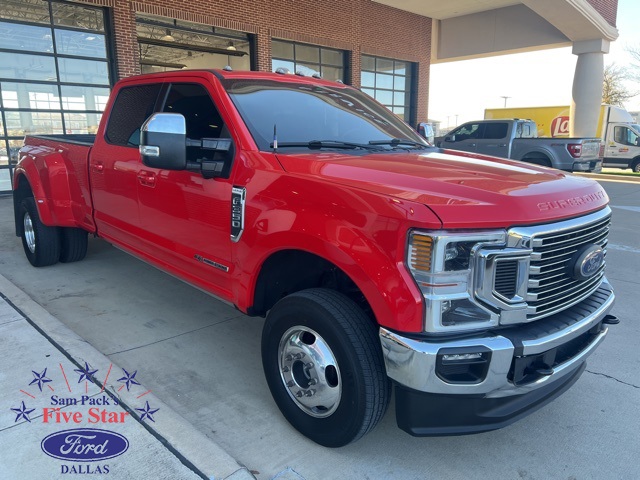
[277,149,608,228]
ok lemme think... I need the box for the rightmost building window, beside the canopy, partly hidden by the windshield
[360,55,415,124]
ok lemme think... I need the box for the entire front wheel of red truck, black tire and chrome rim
[262,288,391,447]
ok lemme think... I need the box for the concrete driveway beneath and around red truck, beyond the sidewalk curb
[0,175,640,480]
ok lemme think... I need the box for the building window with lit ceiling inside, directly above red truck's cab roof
[136,14,253,73]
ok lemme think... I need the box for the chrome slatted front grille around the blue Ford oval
[510,208,611,321]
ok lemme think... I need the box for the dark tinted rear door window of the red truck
[105,83,161,148]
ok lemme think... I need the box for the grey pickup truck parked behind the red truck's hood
[436,119,604,172]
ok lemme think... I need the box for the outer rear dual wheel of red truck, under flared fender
[20,197,60,267]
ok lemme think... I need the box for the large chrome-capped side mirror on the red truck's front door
[140,113,187,170]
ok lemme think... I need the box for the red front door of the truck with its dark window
[138,83,233,297]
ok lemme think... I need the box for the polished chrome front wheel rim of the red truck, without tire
[278,326,342,418]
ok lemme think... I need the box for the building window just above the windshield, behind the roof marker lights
[271,40,345,81]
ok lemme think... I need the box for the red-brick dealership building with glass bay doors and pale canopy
[0,0,617,191]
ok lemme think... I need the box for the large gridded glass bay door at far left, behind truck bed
[0,0,112,191]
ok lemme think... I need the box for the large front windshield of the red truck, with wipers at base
[222,79,428,151]
